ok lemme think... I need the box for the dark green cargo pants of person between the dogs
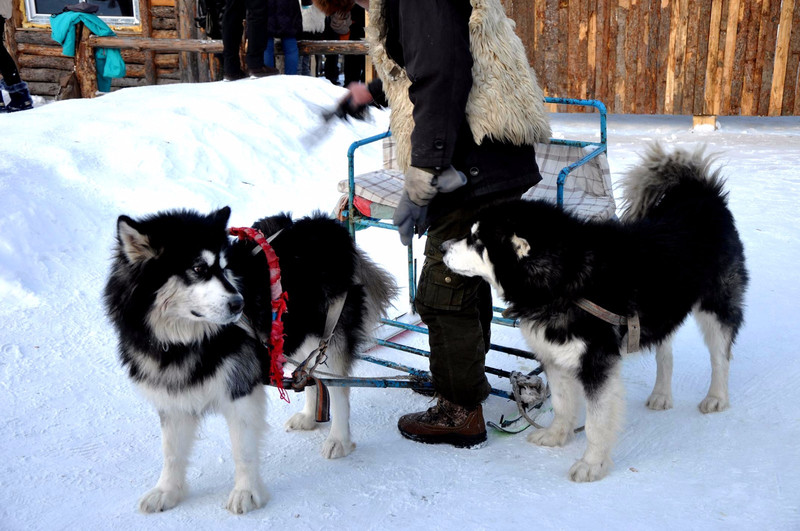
[415,209,492,408]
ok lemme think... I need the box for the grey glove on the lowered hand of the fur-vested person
[392,166,467,245]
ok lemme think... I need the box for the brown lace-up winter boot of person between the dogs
[397,397,486,448]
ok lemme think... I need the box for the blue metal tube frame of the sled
[340,98,608,399]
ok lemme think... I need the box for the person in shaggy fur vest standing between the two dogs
[315,0,550,447]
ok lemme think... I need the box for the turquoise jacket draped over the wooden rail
[50,11,125,92]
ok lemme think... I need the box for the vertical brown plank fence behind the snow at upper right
[503,0,800,116]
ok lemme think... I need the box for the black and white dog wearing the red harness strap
[105,207,396,513]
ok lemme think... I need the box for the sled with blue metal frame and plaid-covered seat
[324,98,616,429]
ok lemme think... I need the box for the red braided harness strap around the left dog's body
[229,227,289,403]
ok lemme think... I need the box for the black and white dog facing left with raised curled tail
[443,145,748,481]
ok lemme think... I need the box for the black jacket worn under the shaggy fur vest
[372,0,541,221]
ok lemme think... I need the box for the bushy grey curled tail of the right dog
[620,143,724,221]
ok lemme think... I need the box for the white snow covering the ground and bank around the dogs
[0,76,800,531]
